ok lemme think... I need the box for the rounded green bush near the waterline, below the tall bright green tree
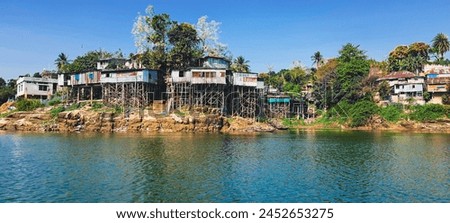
[349,100,378,127]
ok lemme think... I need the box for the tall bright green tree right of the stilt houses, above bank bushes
[333,43,370,103]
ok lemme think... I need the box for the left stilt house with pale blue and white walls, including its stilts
[58,58,158,107]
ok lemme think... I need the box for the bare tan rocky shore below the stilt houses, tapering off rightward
[0,109,276,133]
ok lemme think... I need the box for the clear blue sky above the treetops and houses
[0,0,450,79]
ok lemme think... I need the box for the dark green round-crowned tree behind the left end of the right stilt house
[168,23,202,69]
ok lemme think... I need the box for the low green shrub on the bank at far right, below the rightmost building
[410,104,448,121]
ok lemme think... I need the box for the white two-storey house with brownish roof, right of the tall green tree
[377,71,425,105]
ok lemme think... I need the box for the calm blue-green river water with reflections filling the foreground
[0,131,450,202]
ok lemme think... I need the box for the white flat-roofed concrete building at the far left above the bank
[16,77,58,99]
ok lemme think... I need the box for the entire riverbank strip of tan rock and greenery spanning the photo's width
[0,105,450,134]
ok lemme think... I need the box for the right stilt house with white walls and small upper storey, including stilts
[167,56,264,118]
